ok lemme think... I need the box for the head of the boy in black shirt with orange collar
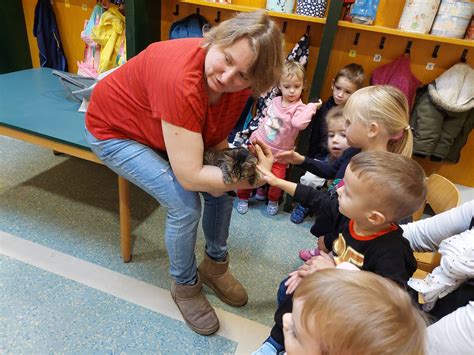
[337,151,426,225]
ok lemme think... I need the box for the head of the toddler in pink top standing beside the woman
[279,60,305,104]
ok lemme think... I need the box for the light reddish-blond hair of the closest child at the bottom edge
[294,269,426,355]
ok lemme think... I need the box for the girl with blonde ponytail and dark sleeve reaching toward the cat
[286,85,413,255]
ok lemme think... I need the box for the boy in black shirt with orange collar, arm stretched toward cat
[252,151,426,354]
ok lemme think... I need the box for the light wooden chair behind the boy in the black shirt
[413,174,461,278]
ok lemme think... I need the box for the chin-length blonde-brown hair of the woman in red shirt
[202,10,283,95]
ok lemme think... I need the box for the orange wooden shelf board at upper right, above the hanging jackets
[338,21,474,47]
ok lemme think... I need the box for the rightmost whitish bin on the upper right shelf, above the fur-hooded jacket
[431,0,474,38]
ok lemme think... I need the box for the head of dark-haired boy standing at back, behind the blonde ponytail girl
[331,63,365,106]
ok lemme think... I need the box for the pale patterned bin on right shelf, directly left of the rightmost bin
[398,0,440,33]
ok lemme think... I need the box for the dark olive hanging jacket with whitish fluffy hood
[410,63,474,162]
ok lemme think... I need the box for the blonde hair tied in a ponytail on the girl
[344,85,413,157]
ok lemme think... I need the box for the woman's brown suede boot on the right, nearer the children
[198,253,248,307]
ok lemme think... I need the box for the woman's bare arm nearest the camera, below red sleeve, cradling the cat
[162,120,273,193]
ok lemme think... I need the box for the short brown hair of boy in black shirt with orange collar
[349,151,426,222]
